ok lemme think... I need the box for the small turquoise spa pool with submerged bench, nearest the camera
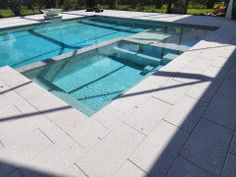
[22,41,182,116]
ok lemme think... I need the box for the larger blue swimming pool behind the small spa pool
[0,16,213,68]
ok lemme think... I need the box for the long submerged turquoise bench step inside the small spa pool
[113,47,161,66]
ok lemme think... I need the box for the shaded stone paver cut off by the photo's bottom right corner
[221,154,236,177]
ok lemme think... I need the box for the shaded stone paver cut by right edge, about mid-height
[203,95,236,129]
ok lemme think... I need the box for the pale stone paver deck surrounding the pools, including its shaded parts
[0,11,236,177]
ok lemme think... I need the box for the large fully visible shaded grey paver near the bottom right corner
[181,119,232,176]
